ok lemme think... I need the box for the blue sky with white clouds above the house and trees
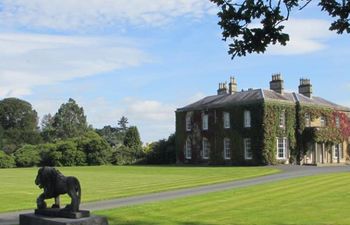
[0,0,350,143]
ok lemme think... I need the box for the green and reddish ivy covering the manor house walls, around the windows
[176,101,350,165]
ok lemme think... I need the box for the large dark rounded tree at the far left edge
[0,98,40,152]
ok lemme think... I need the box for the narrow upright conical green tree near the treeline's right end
[124,126,142,159]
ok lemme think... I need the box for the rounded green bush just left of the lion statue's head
[14,145,41,167]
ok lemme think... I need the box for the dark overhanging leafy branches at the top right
[210,0,350,58]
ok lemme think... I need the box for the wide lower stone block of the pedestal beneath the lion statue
[19,213,108,225]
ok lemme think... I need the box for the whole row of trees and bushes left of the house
[0,98,176,168]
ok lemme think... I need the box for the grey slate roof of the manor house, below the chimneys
[177,89,350,112]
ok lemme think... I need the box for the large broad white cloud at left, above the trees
[0,33,148,98]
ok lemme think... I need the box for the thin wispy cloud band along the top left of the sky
[0,0,214,30]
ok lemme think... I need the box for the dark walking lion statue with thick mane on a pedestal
[35,167,81,212]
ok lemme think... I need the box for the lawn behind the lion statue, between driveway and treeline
[0,166,279,212]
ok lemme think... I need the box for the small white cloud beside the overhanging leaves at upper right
[267,19,334,55]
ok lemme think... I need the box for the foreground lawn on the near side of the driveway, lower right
[97,173,350,225]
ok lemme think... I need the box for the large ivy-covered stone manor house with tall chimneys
[176,74,350,165]
